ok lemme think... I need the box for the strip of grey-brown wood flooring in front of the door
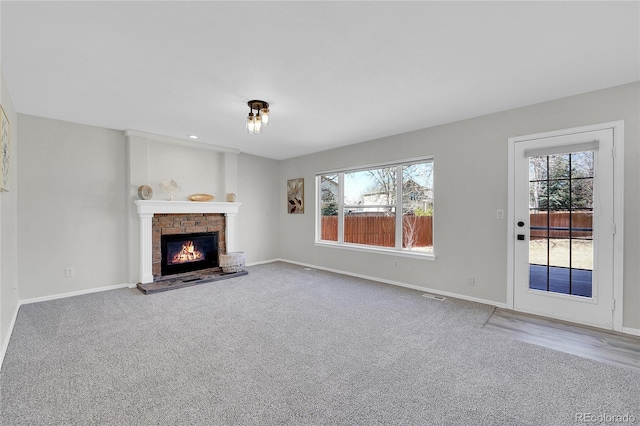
[484,308,640,372]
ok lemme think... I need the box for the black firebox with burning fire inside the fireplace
[160,232,218,275]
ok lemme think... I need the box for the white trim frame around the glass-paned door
[507,120,624,332]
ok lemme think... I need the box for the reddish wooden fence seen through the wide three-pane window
[321,216,433,247]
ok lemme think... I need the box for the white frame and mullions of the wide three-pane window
[315,156,436,260]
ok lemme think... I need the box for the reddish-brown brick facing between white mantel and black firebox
[151,213,227,279]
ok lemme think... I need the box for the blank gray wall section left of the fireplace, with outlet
[18,114,128,300]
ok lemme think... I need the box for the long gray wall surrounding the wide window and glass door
[279,83,640,329]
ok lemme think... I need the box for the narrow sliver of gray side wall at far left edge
[0,73,18,362]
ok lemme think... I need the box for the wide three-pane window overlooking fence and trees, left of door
[317,159,433,254]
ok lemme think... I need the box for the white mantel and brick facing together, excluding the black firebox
[136,200,240,284]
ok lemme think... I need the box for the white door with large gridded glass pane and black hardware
[512,129,614,329]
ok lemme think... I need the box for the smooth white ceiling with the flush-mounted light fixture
[1,1,640,159]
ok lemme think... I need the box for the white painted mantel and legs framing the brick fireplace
[136,200,242,284]
